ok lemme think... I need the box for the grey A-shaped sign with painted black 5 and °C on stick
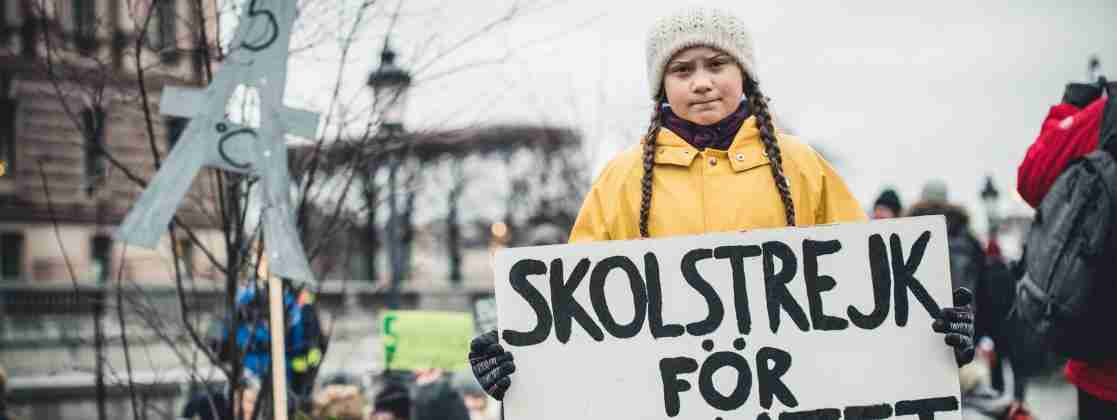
[116,0,318,285]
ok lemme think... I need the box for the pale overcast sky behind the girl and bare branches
[279,0,1117,236]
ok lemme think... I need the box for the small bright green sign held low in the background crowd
[381,311,474,371]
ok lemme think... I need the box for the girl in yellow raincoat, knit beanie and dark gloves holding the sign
[469,5,973,400]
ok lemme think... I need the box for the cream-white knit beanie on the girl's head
[648,8,757,99]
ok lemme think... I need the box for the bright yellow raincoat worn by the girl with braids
[570,117,867,242]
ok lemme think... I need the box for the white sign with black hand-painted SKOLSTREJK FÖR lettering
[494,217,961,420]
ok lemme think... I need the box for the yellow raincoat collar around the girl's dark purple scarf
[641,116,768,172]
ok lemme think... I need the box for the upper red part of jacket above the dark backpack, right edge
[1016,96,1106,207]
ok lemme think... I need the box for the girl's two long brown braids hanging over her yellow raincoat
[640,77,795,238]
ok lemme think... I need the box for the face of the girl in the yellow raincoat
[663,47,744,125]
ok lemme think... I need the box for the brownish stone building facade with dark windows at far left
[0,0,225,419]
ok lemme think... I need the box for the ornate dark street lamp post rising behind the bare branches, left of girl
[367,40,411,309]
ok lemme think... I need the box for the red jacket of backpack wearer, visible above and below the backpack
[1016,96,1117,401]
